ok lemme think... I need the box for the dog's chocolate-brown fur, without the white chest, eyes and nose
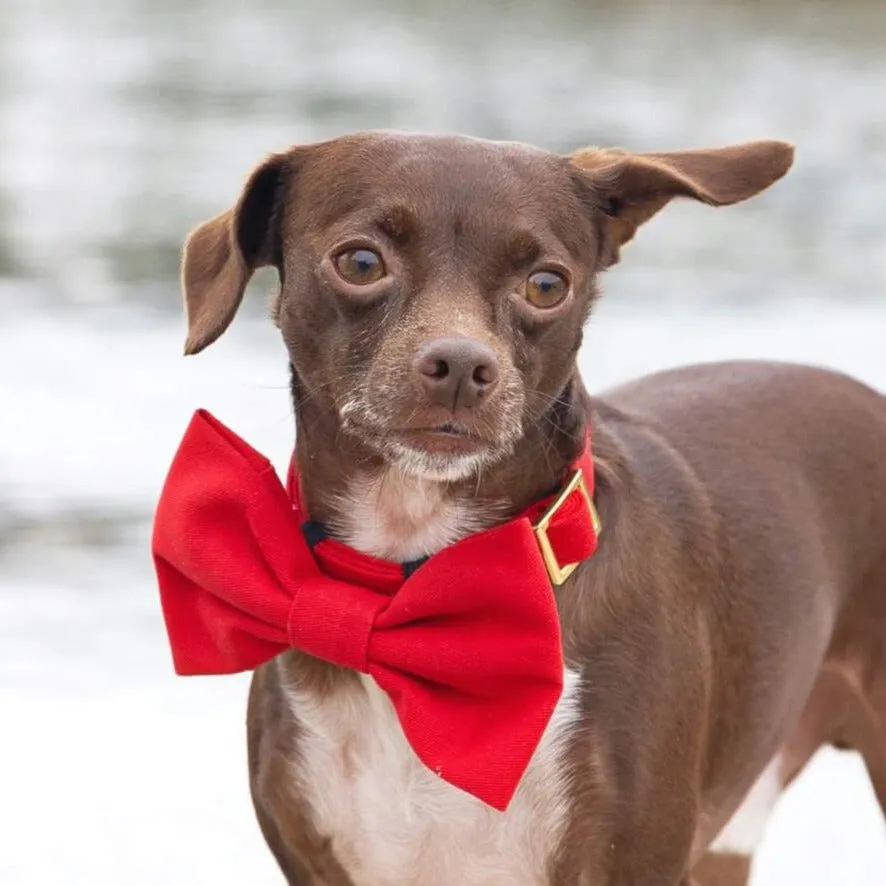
[177,134,886,886]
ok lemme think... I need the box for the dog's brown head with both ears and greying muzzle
[183,133,793,481]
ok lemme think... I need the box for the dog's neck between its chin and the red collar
[293,372,588,562]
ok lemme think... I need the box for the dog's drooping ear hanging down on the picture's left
[182,154,290,354]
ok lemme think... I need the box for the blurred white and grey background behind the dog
[0,0,886,886]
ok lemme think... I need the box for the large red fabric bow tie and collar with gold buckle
[153,411,599,809]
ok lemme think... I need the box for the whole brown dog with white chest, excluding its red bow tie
[183,134,886,886]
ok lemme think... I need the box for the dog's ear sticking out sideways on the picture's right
[570,141,794,266]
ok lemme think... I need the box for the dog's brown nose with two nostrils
[414,336,498,412]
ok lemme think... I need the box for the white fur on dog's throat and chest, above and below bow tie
[280,468,579,886]
